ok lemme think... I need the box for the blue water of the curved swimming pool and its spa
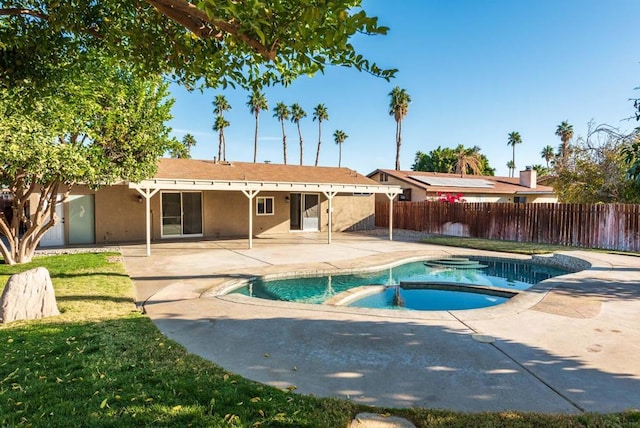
[232,257,569,310]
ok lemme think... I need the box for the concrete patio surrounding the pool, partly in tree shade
[122,233,640,413]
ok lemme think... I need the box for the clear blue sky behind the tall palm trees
[169,0,640,176]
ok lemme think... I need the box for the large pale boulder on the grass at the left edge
[0,267,60,323]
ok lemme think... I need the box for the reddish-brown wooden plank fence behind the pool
[376,201,640,252]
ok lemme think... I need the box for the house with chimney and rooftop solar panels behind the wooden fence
[368,169,558,203]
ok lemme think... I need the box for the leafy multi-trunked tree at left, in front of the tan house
[0,59,180,264]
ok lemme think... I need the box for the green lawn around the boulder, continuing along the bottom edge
[0,253,640,428]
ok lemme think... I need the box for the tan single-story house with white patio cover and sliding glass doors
[41,159,401,246]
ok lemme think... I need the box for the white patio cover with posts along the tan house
[129,178,402,256]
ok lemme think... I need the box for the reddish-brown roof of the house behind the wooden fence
[369,169,554,194]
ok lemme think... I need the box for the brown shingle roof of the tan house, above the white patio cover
[154,158,380,185]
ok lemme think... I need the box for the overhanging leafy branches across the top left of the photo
[0,0,395,89]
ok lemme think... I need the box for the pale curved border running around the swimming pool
[199,250,600,320]
